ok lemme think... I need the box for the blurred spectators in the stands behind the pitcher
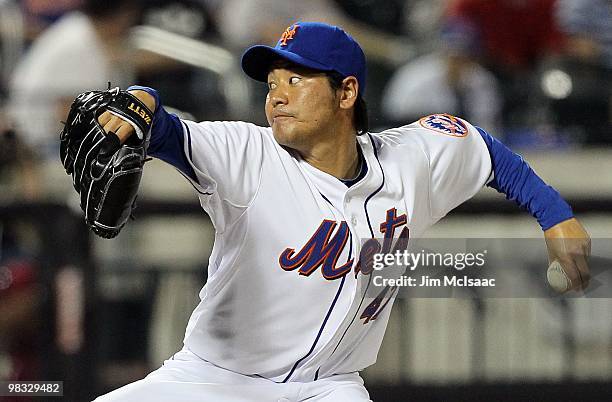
[0,0,612,392]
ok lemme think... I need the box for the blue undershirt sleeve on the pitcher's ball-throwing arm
[476,127,574,230]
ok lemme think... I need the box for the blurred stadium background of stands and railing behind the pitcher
[0,0,612,402]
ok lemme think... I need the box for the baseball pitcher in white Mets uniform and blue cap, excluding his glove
[89,22,590,402]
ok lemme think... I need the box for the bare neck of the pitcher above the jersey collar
[300,132,360,179]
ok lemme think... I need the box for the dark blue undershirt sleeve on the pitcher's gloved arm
[127,85,198,182]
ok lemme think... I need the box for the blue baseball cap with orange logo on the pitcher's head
[242,22,366,94]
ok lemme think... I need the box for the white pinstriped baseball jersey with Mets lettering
[175,115,492,382]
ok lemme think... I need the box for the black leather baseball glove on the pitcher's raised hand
[60,88,153,239]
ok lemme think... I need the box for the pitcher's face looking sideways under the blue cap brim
[266,63,339,150]
